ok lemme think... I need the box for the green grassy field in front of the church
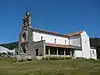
[0,59,100,75]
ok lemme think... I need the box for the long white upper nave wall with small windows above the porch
[33,32,69,45]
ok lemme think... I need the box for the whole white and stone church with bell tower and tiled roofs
[18,12,97,59]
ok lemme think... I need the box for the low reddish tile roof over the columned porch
[46,43,81,49]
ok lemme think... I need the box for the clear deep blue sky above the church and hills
[0,0,100,43]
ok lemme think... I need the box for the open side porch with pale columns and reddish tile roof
[45,44,80,57]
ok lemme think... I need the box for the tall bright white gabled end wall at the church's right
[81,31,90,59]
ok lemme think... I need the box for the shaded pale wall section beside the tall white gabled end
[70,36,81,47]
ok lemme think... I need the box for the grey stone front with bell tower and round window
[19,11,34,58]
